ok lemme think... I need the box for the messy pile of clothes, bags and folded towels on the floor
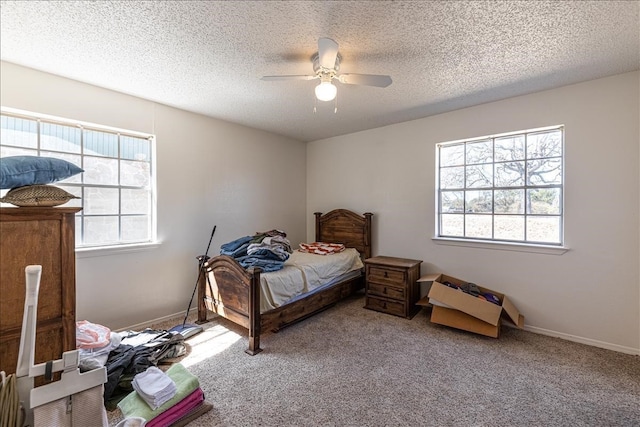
[76,321,211,427]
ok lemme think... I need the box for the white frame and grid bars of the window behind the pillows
[0,107,159,257]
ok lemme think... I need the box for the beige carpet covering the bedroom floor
[110,295,640,427]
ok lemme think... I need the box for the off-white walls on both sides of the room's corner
[0,62,640,354]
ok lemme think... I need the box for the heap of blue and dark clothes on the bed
[220,229,293,272]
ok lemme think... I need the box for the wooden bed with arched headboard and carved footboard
[198,209,373,355]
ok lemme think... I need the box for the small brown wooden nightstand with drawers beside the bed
[364,256,422,319]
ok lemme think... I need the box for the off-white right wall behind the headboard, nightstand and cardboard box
[307,72,640,354]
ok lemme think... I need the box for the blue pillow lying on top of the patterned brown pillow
[0,156,84,189]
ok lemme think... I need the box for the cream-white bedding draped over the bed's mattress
[260,248,364,312]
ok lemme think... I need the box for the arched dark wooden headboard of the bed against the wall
[314,209,373,259]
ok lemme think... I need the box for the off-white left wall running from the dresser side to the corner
[0,62,306,329]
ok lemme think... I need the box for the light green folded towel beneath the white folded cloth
[118,363,200,421]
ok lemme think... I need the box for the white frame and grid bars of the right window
[433,125,568,254]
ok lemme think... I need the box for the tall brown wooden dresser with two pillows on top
[0,207,80,374]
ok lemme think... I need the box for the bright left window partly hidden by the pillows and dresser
[0,109,156,248]
